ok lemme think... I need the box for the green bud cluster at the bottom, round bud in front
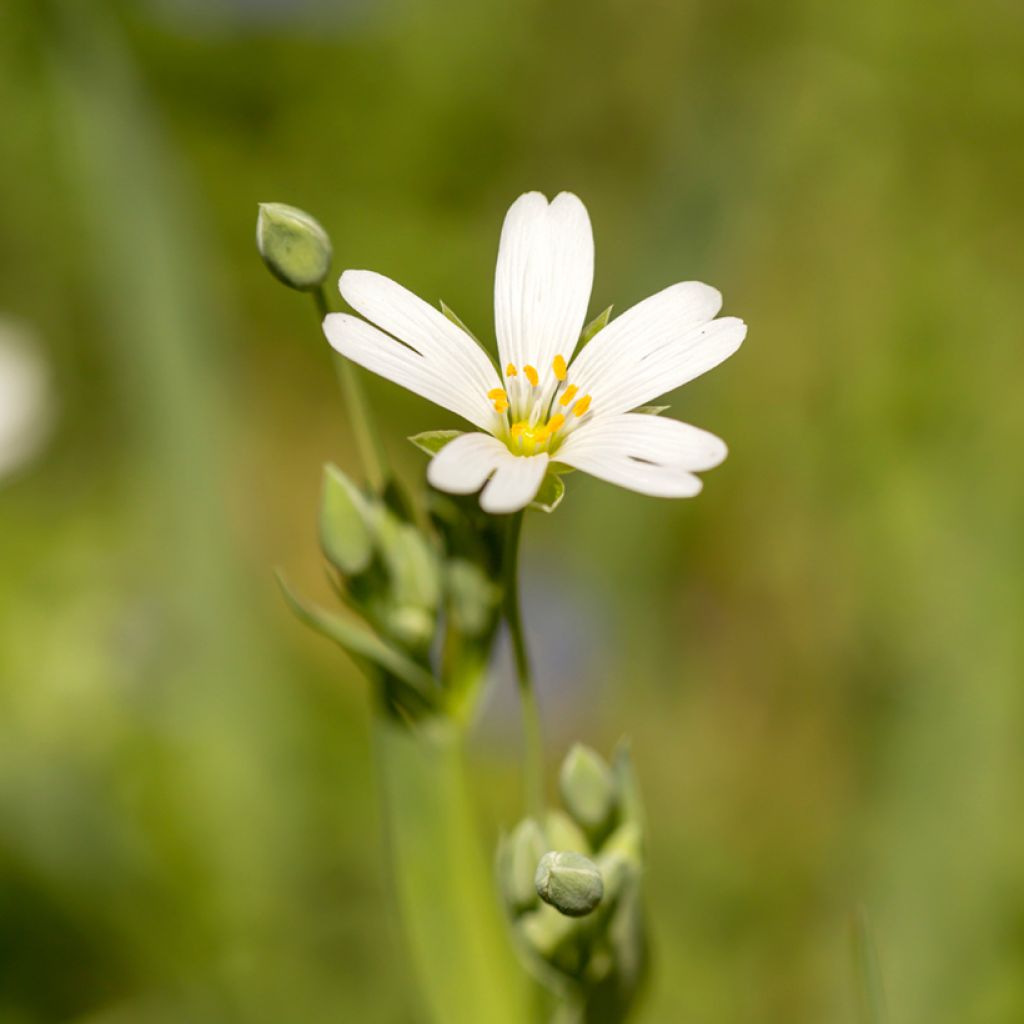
[498,742,647,1021]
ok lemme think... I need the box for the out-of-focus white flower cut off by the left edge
[0,317,53,479]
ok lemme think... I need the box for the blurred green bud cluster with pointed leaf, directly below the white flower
[285,465,502,721]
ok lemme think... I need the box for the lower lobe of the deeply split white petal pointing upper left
[324,313,498,430]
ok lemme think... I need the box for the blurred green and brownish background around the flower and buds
[0,0,1024,1024]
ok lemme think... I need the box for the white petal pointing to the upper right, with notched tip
[569,282,746,415]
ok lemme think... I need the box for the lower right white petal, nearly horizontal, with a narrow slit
[555,413,728,498]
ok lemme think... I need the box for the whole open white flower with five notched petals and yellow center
[324,193,746,513]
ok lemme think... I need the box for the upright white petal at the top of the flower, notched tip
[495,193,594,375]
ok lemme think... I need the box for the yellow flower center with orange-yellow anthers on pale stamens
[487,355,590,456]
